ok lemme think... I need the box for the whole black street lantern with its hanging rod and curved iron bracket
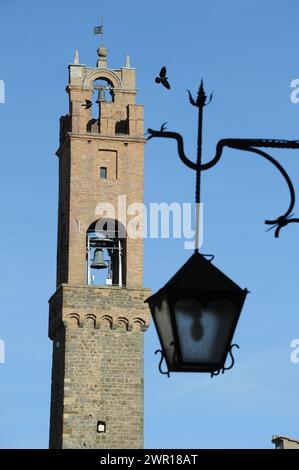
[146,81,299,376]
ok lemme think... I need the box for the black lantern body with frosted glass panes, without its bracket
[146,253,248,374]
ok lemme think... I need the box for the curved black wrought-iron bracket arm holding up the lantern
[147,129,299,238]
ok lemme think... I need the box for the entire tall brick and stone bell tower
[49,46,149,448]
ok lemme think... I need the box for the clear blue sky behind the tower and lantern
[0,0,299,448]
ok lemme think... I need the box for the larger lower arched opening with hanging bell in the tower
[86,219,126,287]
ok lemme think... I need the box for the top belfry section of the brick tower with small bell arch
[60,47,144,140]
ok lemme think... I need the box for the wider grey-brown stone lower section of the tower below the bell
[49,285,150,448]
